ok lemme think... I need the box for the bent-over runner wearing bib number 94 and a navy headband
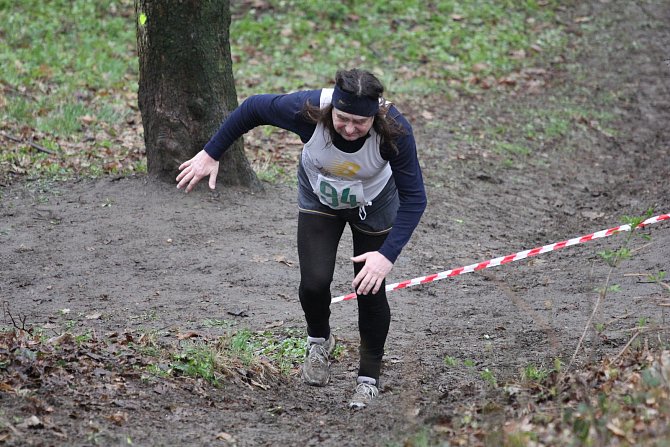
[177,69,426,409]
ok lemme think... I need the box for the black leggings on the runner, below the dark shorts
[298,212,391,383]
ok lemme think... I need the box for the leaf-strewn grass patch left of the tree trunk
[0,0,146,180]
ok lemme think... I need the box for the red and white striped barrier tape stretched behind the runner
[331,214,670,303]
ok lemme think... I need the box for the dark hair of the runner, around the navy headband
[303,68,405,160]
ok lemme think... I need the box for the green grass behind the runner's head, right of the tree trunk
[231,0,564,96]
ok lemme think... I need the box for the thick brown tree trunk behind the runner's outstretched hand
[135,0,261,189]
